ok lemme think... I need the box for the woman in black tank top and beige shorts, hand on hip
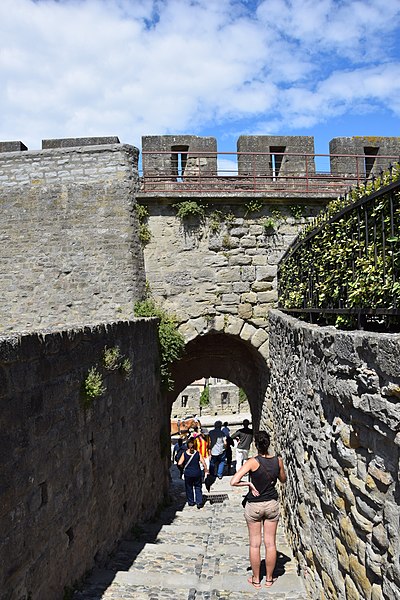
[230,431,286,589]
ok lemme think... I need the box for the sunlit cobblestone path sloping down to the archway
[73,466,307,600]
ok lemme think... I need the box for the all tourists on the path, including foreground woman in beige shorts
[172,419,286,589]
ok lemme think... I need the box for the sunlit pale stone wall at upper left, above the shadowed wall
[0,138,145,331]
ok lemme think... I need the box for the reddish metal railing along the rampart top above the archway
[140,151,399,197]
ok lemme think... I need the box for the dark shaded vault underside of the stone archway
[168,332,269,429]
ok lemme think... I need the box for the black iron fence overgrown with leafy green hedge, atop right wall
[278,167,400,327]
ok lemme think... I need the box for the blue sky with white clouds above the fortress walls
[0,0,400,162]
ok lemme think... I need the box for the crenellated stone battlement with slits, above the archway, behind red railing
[141,135,400,198]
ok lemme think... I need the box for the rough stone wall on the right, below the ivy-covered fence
[264,311,400,600]
